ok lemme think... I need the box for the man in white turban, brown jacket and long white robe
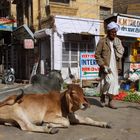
[95,21,124,109]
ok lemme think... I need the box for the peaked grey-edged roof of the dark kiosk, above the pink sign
[13,24,34,40]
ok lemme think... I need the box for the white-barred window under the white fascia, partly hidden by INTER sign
[62,35,95,68]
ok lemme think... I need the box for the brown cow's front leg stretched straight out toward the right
[69,113,111,128]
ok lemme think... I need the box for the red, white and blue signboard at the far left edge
[0,18,15,31]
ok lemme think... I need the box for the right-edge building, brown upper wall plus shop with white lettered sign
[113,0,140,73]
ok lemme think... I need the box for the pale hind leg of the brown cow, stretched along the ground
[13,107,58,134]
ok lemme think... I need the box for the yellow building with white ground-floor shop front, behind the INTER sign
[35,0,113,79]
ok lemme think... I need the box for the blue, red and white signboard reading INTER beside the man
[80,52,99,79]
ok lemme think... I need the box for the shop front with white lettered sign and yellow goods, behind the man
[105,13,140,74]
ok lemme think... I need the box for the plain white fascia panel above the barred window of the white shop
[55,15,103,35]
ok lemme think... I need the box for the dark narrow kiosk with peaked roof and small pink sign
[12,24,35,82]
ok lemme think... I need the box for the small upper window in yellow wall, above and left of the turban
[100,7,111,20]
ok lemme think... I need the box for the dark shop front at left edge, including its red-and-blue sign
[0,17,16,75]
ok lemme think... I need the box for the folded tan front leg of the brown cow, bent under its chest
[43,114,70,128]
